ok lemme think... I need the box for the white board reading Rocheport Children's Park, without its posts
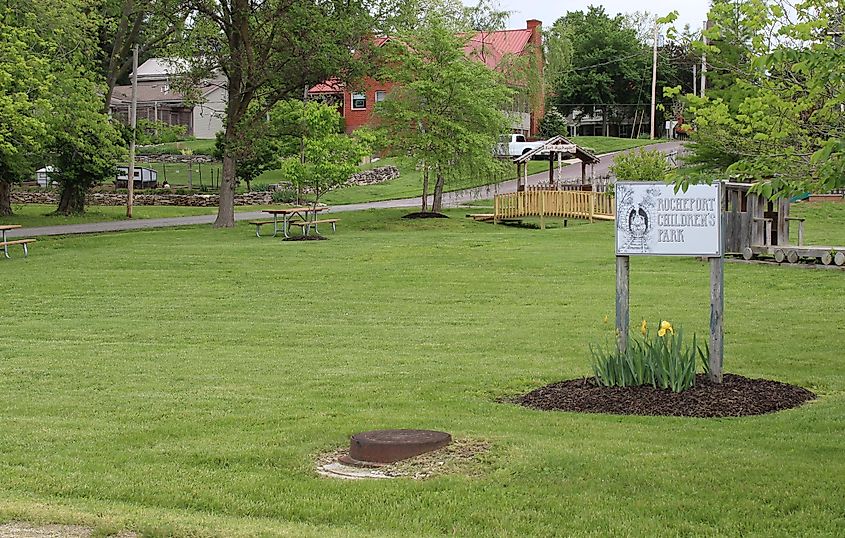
[616,181,722,257]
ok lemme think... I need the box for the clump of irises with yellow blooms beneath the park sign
[590,321,710,392]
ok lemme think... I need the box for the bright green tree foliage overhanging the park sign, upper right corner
[679,0,845,196]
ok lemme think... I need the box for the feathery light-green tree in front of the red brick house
[376,16,514,211]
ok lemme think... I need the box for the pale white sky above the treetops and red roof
[463,0,710,30]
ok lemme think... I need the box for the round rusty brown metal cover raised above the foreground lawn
[349,430,452,463]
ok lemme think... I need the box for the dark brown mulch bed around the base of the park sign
[504,374,816,418]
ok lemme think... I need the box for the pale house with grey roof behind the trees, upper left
[109,58,227,139]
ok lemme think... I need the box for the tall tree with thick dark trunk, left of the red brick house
[183,0,371,227]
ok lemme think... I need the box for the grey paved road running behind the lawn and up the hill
[7,142,681,238]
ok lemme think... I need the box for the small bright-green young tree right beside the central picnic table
[282,101,371,207]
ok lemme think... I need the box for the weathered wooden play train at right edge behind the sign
[723,183,845,266]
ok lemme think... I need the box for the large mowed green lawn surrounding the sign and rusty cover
[0,204,845,537]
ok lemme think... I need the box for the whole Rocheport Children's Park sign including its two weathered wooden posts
[616,181,725,383]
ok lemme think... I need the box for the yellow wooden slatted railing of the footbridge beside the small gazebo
[493,189,615,227]
